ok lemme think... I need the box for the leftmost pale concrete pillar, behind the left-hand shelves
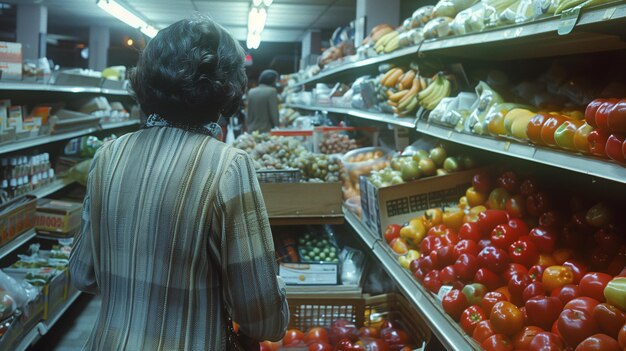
[16,4,48,60]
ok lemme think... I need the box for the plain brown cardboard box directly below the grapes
[261,182,342,218]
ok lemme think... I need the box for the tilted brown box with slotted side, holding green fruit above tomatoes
[360,169,476,236]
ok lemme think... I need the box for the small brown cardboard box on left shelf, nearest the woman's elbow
[35,199,83,234]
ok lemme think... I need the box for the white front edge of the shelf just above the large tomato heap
[417,121,626,183]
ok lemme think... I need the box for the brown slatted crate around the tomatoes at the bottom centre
[287,293,431,346]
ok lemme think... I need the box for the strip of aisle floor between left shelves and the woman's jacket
[32,294,102,351]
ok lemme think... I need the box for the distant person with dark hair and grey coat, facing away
[246,69,278,133]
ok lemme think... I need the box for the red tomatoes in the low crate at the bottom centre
[260,319,413,351]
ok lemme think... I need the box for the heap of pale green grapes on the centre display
[233,132,339,182]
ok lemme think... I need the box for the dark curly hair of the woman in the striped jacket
[130,16,247,125]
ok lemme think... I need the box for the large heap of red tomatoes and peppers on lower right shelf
[385,171,626,351]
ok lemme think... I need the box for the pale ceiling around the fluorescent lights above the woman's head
[0,0,356,42]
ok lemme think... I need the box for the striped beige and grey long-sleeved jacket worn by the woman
[70,127,289,351]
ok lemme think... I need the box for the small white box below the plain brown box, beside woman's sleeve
[278,263,339,285]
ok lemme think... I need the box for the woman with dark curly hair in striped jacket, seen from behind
[70,18,289,351]
